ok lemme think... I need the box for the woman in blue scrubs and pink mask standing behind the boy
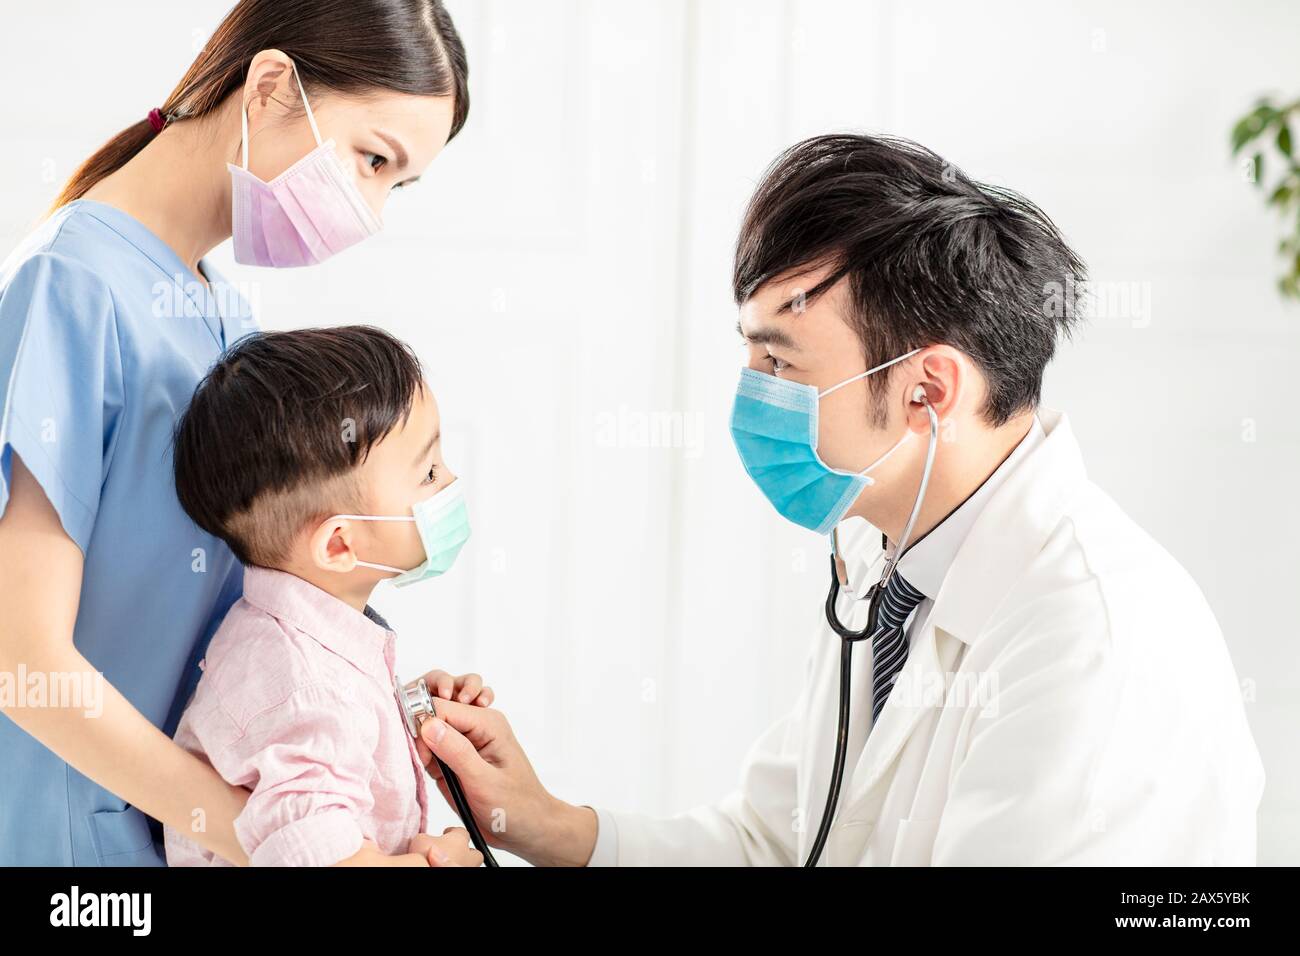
[0,0,468,865]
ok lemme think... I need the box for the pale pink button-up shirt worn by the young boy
[164,567,428,866]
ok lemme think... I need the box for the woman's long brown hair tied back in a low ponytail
[49,0,469,212]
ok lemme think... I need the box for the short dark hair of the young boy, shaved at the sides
[174,325,424,567]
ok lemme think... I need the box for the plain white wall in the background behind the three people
[0,0,1300,864]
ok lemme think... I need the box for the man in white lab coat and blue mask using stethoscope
[424,135,1264,865]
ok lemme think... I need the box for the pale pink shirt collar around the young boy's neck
[243,567,397,687]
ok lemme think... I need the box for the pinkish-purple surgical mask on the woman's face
[226,66,384,269]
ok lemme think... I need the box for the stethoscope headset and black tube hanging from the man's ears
[803,385,939,866]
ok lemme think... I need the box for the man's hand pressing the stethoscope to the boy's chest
[420,701,597,866]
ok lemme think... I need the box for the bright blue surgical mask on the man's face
[731,349,920,535]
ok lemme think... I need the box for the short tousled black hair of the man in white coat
[732,134,1086,425]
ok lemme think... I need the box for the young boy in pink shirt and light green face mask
[164,326,491,866]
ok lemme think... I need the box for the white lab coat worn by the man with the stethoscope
[599,408,1264,866]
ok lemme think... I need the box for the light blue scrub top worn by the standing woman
[0,199,255,866]
